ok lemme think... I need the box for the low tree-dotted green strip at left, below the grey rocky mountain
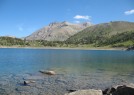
[0,36,64,47]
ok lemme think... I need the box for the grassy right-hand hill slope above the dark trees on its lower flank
[66,21,134,45]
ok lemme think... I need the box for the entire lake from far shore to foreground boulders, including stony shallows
[0,49,134,95]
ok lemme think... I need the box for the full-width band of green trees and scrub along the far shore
[0,31,134,48]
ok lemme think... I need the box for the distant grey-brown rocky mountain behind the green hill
[25,21,91,41]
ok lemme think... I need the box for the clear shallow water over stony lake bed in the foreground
[0,73,134,95]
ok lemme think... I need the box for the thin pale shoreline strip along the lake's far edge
[0,46,127,50]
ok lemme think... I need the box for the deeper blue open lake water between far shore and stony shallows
[0,48,134,75]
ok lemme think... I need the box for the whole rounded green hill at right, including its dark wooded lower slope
[66,21,134,47]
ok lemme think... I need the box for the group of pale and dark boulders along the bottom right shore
[65,84,134,95]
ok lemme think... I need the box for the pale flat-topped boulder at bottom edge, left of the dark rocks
[65,89,102,95]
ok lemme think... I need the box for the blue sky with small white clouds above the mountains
[0,0,134,37]
